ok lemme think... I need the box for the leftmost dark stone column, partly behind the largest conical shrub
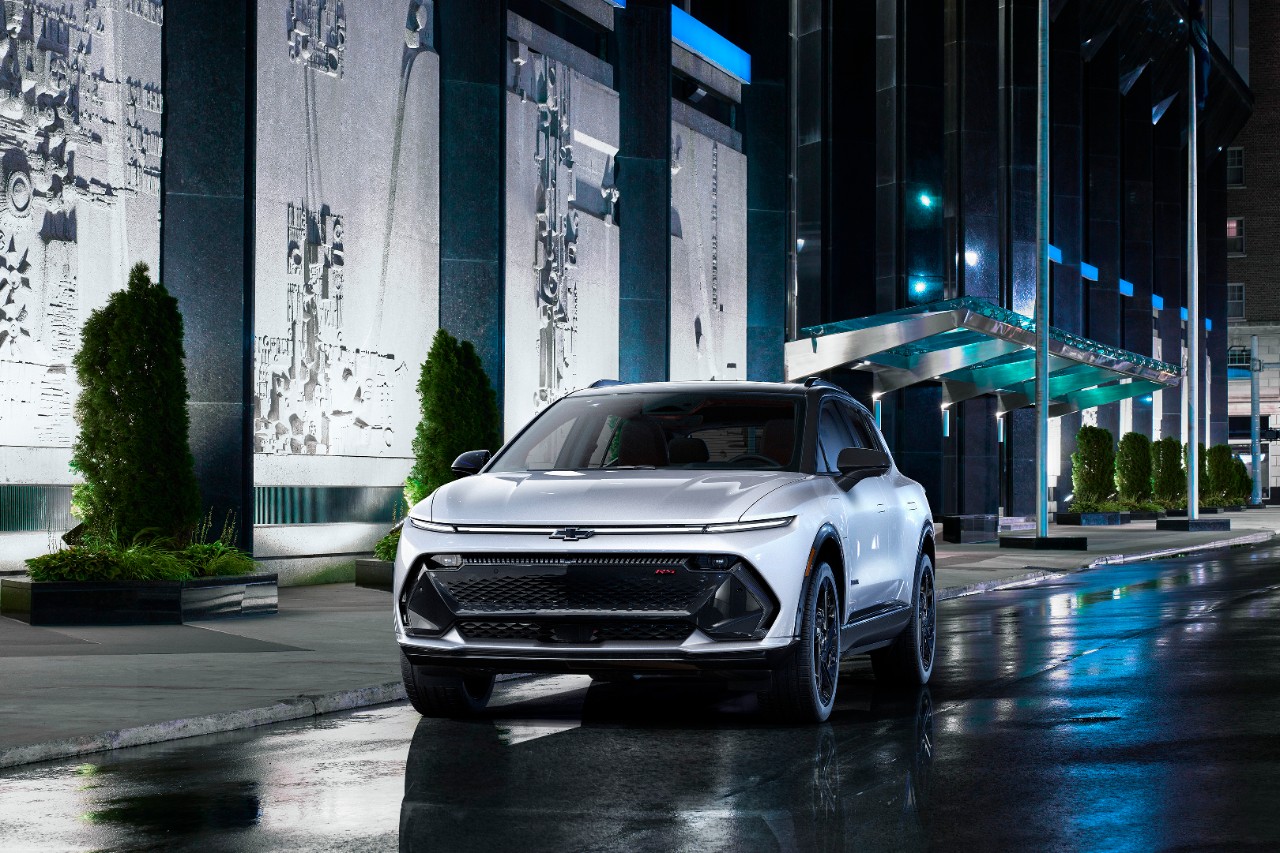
[159,0,257,551]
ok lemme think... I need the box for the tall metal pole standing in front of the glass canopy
[1036,0,1050,537]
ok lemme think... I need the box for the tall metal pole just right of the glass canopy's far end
[1187,44,1201,519]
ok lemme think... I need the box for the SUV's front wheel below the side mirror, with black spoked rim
[760,562,842,722]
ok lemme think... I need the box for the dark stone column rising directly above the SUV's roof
[613,0,671,382]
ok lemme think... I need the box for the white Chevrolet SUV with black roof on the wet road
[393,380,937,721]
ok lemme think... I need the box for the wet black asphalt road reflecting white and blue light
[0,540,1280,852]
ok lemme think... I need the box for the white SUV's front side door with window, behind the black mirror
[815,400,891,621]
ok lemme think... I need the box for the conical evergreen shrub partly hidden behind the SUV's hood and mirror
[404,329,502,506]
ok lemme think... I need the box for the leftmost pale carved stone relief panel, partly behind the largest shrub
[0,0,164,447]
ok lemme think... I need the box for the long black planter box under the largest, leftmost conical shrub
[0,574,278,625]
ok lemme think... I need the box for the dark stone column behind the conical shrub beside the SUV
[435,0,507,399]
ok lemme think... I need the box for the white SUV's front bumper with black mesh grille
[394,517,813,674]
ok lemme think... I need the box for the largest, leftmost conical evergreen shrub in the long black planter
[72,264,200,543]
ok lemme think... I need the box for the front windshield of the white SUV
[489,391,803,473]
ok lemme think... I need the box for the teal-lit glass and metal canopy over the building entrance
[785,297,1181,418]
